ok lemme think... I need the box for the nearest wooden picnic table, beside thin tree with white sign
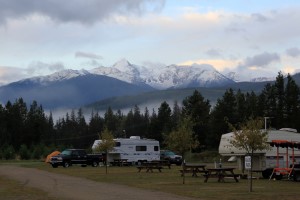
[203,167,239,182]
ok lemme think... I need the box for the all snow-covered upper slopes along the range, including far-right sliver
[9,59,275,90]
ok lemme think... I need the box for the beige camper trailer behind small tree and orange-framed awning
[219,128,300,178]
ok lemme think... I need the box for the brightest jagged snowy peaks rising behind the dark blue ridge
[90,59,234,89]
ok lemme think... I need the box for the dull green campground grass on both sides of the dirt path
[0,162,300,200]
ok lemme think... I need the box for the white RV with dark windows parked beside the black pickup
[92,136,160,163]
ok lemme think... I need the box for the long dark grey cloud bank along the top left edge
[0,0,165,24]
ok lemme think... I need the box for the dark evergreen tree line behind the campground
[0,72,300,159]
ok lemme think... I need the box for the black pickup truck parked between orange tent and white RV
[50,149,103,168]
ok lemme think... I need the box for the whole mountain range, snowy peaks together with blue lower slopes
[0,59,282,109]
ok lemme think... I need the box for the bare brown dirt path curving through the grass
[0,165,197,200]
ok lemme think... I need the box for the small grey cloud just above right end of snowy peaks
[242,52,280,67]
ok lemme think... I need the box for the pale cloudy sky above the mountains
[0,0,300,85]
